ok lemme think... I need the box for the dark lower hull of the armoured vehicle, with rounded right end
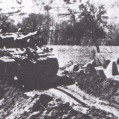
[0,47,58,87]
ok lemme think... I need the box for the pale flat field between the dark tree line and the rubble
[48,45,119,67]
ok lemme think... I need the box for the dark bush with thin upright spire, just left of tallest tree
[60,8,84,45]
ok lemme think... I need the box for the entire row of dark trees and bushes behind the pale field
[0,1,119,52]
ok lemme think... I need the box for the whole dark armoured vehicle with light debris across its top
[0,32,58,87]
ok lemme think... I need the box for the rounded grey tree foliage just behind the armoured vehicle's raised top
[18,13,53,44]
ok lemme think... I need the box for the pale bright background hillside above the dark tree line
[0,0,119,23]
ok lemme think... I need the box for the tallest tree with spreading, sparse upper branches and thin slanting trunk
[79,1,107,52]
